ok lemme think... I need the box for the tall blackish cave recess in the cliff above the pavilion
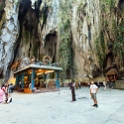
[17,0,42,58]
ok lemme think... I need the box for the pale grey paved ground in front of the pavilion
[0,87,124,124]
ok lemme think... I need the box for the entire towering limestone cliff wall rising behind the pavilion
[0,0,124,79]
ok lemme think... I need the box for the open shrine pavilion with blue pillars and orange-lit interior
[14,64,63,91]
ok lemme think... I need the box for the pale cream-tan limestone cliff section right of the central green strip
[72,0,100,78]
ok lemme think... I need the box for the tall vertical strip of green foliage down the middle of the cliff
[58,0,74,78]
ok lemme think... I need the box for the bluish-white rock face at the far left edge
[0,0,19,79]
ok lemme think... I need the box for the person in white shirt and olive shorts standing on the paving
[90,81,98,107]
